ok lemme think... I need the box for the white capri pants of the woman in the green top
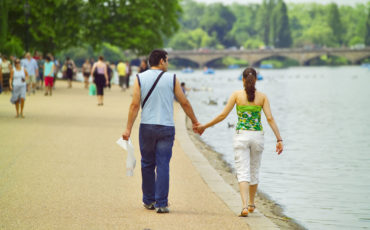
[233,130,264,185]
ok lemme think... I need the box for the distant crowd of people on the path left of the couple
[0,51,144,118]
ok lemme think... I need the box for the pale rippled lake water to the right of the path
[177,66,370,229]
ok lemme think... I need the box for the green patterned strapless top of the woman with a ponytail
[236,105,263,131]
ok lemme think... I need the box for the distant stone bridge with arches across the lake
[168,47,370,67]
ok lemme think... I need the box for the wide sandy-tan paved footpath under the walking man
[0,81,268,230]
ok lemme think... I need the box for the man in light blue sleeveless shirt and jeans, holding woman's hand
[122,50,199,213]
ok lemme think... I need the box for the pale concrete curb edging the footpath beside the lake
[176,110,279,230]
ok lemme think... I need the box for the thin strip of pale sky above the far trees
[195,0,370,5]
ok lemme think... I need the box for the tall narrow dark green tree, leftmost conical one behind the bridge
[273,0,292,48]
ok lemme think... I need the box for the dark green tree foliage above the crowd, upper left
[0,0,181,54]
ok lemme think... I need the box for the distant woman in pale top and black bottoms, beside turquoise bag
[91,56,109,106]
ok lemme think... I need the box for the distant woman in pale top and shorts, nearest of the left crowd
[9,59,28,118]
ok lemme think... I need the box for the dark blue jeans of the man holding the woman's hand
[139,124,175,208]
